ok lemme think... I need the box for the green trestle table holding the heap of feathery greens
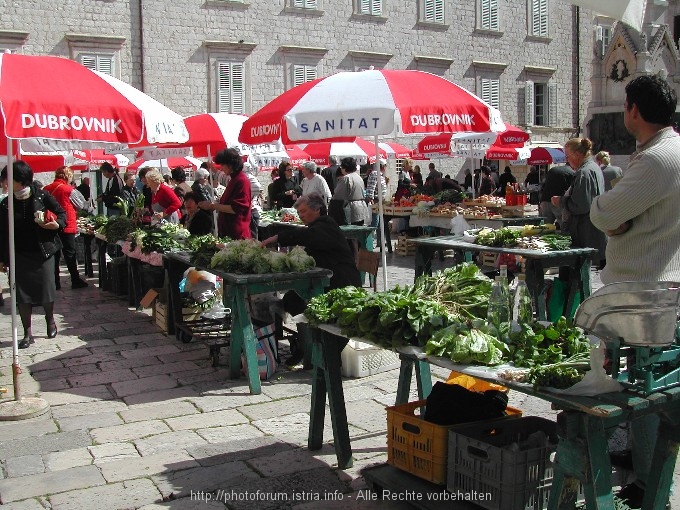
[163,252,333,395]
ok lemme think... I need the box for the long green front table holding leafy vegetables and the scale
[308,324,680,510]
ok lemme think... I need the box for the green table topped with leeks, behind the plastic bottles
[411,235,596,320]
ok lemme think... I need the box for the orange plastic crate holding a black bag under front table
[386,400,522,485]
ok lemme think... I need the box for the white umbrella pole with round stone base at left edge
[0,138,49,421]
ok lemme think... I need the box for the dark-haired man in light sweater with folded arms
[590,76,680,508]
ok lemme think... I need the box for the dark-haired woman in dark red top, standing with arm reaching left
[199,149,252,239]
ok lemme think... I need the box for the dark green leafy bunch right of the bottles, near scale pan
[508,317,590,367]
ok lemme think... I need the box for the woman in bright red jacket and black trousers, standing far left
[44,166,87,290]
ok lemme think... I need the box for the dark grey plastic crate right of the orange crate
[446,416,557,510]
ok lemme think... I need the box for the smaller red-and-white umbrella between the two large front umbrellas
[162,113,248,158]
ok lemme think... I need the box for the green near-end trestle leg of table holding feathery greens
[225,287,262,395]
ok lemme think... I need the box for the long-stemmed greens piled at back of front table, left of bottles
[412,262,493,319]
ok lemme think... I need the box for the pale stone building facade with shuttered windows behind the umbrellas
[0,0,592,180]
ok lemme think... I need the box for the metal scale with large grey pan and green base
[574,282,680,395]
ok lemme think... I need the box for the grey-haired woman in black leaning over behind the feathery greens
[262,192,361,366]
